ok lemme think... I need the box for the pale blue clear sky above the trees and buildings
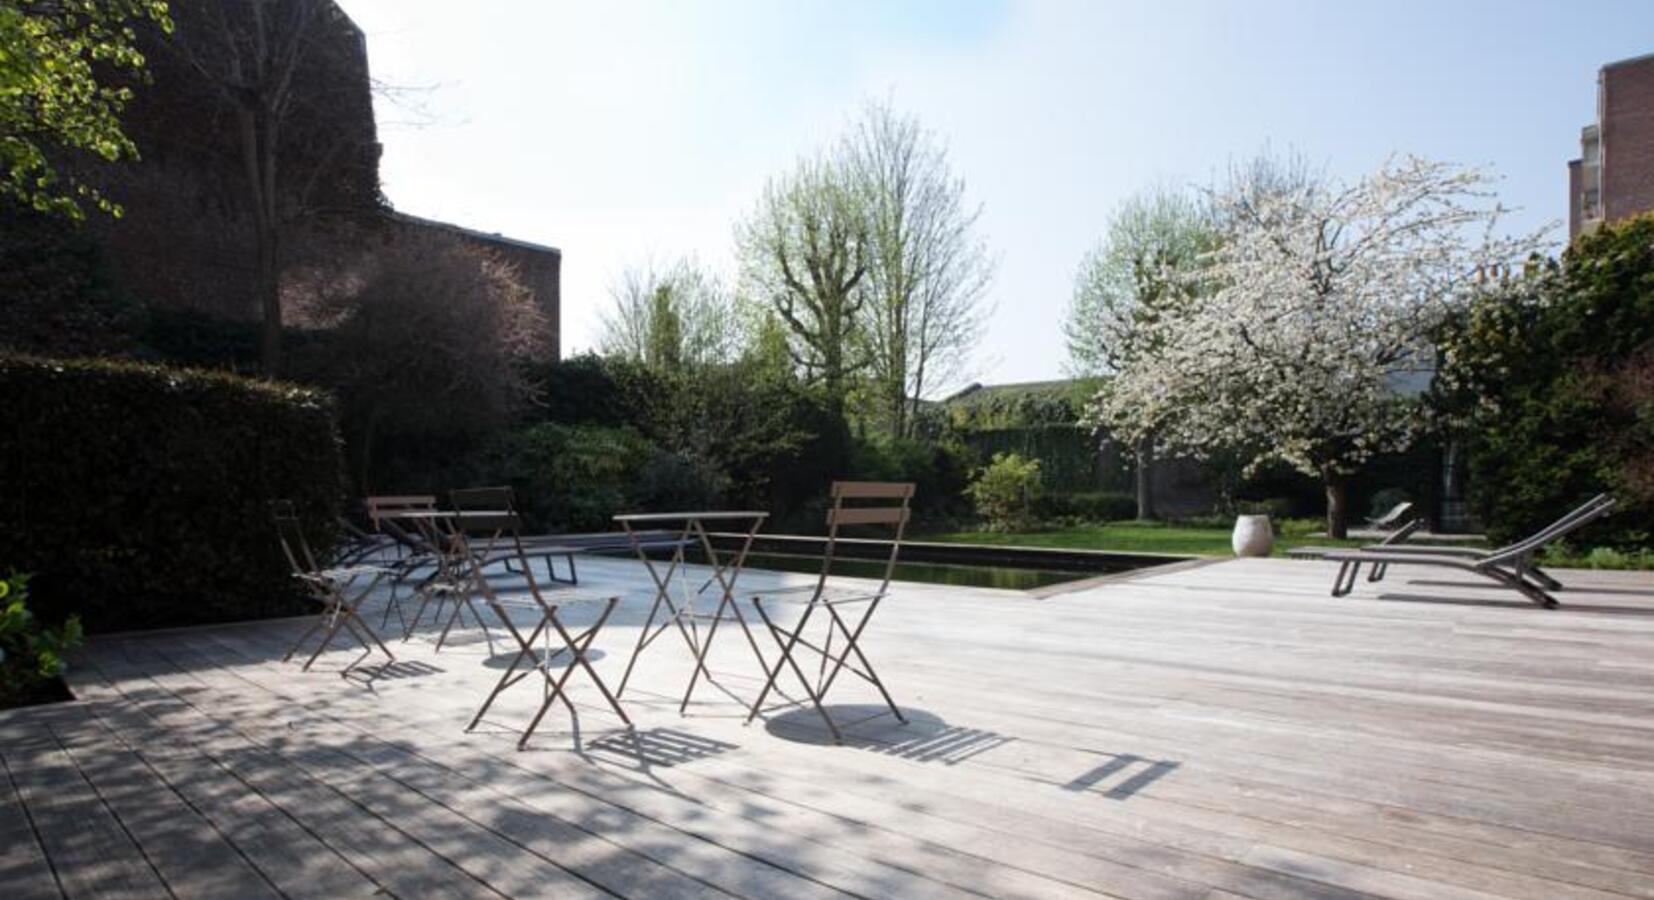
[341,0,1654,390]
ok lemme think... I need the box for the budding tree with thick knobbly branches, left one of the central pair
[736,157,868,415]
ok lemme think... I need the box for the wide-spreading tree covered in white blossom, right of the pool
[1097,157,1540,538]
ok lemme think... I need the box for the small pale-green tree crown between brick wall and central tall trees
[599,260,741,369]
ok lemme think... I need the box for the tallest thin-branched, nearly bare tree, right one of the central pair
[839,103,994,437]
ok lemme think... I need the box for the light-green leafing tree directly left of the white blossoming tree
[1064,187,1214,519]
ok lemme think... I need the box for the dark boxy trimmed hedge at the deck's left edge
[0,356,342,630]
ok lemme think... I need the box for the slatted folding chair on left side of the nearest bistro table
[455,511,632,749]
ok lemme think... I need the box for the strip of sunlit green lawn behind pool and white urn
[918,519,1373,556]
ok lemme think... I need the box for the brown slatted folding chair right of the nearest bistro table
[746,481,913,743]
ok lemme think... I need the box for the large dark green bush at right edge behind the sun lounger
[1436,215,1654,544]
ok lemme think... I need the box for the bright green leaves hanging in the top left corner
[0,0,172,218]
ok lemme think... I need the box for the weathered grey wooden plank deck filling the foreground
[0,561,1654,900]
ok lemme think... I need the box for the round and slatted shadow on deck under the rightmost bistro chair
[764,703,1016,766]
